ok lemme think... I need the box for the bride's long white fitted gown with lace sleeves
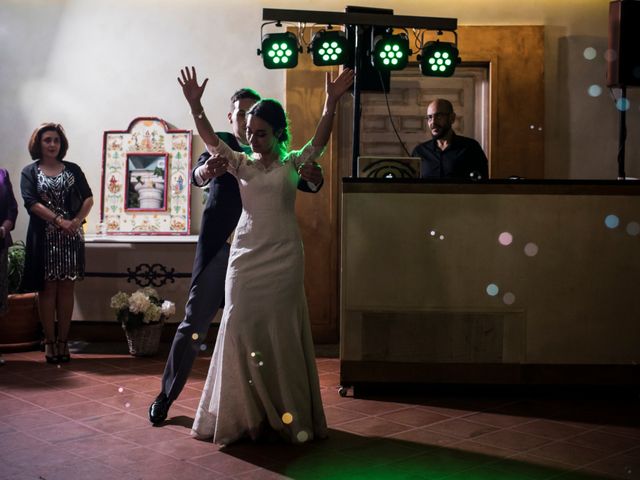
[192,137,327,445]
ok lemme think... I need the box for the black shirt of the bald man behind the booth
[411,133,489,180]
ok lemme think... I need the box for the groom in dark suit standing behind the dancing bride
[149,88,323,425]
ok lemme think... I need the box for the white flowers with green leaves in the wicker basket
[111,287,176,330]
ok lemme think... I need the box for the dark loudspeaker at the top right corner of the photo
[606,0,640,87]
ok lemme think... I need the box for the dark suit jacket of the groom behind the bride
[191,132,322,285]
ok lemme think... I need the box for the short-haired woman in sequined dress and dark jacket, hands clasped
[20,123,93,363]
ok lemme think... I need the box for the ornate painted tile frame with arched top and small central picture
[100,117,192,235]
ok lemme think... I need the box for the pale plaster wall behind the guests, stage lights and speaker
[0,0,640,239]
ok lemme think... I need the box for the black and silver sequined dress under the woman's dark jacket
[37,168,85,280]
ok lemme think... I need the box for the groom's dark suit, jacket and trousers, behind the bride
[162,132,319,404]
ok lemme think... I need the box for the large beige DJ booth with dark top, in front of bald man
[340,178,640,393]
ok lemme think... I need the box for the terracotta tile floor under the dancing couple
[0,345,640,480]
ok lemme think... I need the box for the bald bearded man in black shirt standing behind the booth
[411,98,489,180]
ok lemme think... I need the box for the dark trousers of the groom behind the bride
[162,243,229,402]
